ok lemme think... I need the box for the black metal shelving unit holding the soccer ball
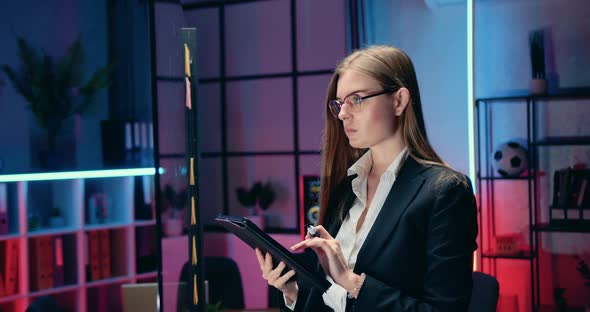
[475,94,590,311]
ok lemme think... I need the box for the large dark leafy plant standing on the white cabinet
[1,37,113,169]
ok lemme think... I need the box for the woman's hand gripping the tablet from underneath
[256,248,297,302]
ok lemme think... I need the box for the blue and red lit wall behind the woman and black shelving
[366,0,590,311]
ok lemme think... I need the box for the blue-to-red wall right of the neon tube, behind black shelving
[474,0,590,311]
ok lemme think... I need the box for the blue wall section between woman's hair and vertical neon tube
[365,0,469,174]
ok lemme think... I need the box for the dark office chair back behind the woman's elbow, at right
[468,272,500,312]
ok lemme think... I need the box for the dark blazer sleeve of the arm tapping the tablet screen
[352,180,477,312]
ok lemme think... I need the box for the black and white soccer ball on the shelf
[492,142,528,177]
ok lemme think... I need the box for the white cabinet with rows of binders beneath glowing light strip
[0,168,158,311]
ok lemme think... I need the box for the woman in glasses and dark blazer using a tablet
[256,46,477,312]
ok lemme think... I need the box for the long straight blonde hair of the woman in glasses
[319,46,447,224]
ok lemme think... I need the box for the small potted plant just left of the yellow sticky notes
[162,184,187,236]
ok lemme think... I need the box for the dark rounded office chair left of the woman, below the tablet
[177,257,245,311]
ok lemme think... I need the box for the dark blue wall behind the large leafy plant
[0,0,107,173]
